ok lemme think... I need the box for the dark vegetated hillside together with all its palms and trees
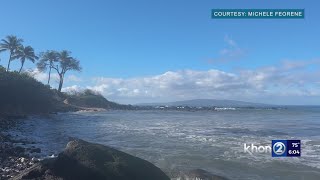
[0,35,132,116]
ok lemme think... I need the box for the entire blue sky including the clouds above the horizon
[0,0,320,104]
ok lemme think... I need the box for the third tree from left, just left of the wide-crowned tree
[37,51,59,84]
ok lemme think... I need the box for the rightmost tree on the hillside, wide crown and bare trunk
[52,50,81,92]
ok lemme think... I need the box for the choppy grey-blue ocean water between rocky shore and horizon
[6,107,320,180]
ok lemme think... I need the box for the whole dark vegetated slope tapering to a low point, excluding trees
[0,66,133,116]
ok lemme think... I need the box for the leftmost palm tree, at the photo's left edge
[0,35,23,71]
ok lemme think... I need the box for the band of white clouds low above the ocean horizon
[29,59,320,104]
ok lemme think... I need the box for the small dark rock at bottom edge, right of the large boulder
[179,169,227,180]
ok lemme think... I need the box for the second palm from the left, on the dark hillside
[13,45,38,73]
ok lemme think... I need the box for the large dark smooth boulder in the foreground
[12,140,170,180]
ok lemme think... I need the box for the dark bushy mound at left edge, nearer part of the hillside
[0,66,60,115]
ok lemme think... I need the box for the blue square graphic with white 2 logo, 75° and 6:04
[272,140,301,157]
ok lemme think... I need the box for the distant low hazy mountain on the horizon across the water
[138,99,271,107]
